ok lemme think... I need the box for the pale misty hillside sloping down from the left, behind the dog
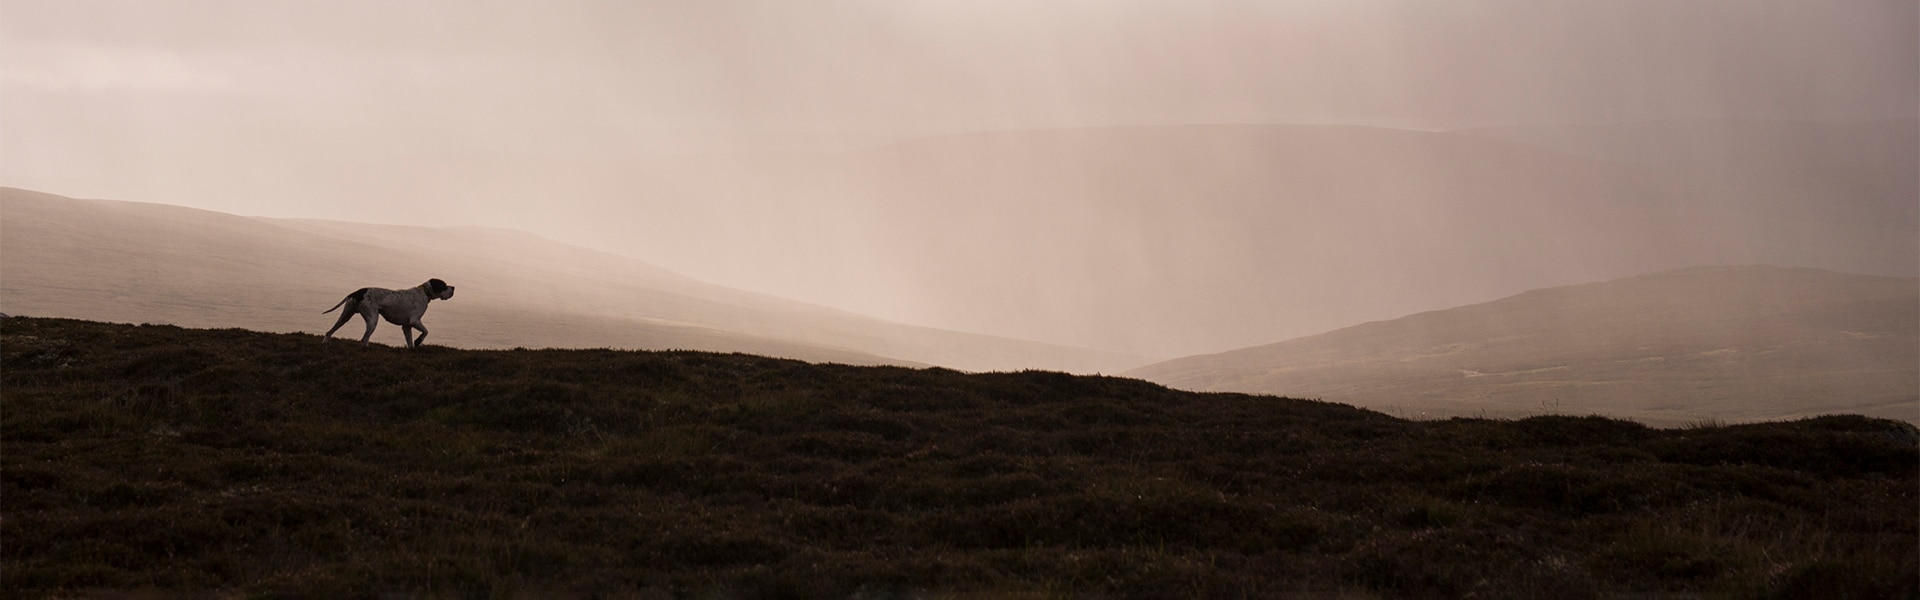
[0,188,1148,373]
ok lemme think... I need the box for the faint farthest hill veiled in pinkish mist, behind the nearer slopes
[541,121,1920,356]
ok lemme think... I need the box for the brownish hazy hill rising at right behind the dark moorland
[1127,267,1920,423]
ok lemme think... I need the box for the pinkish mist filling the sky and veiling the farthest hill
[0,0,1920,358]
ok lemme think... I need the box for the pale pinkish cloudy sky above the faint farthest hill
[0,0,1920,353]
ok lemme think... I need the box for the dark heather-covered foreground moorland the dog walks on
[0,317,1920,598]
